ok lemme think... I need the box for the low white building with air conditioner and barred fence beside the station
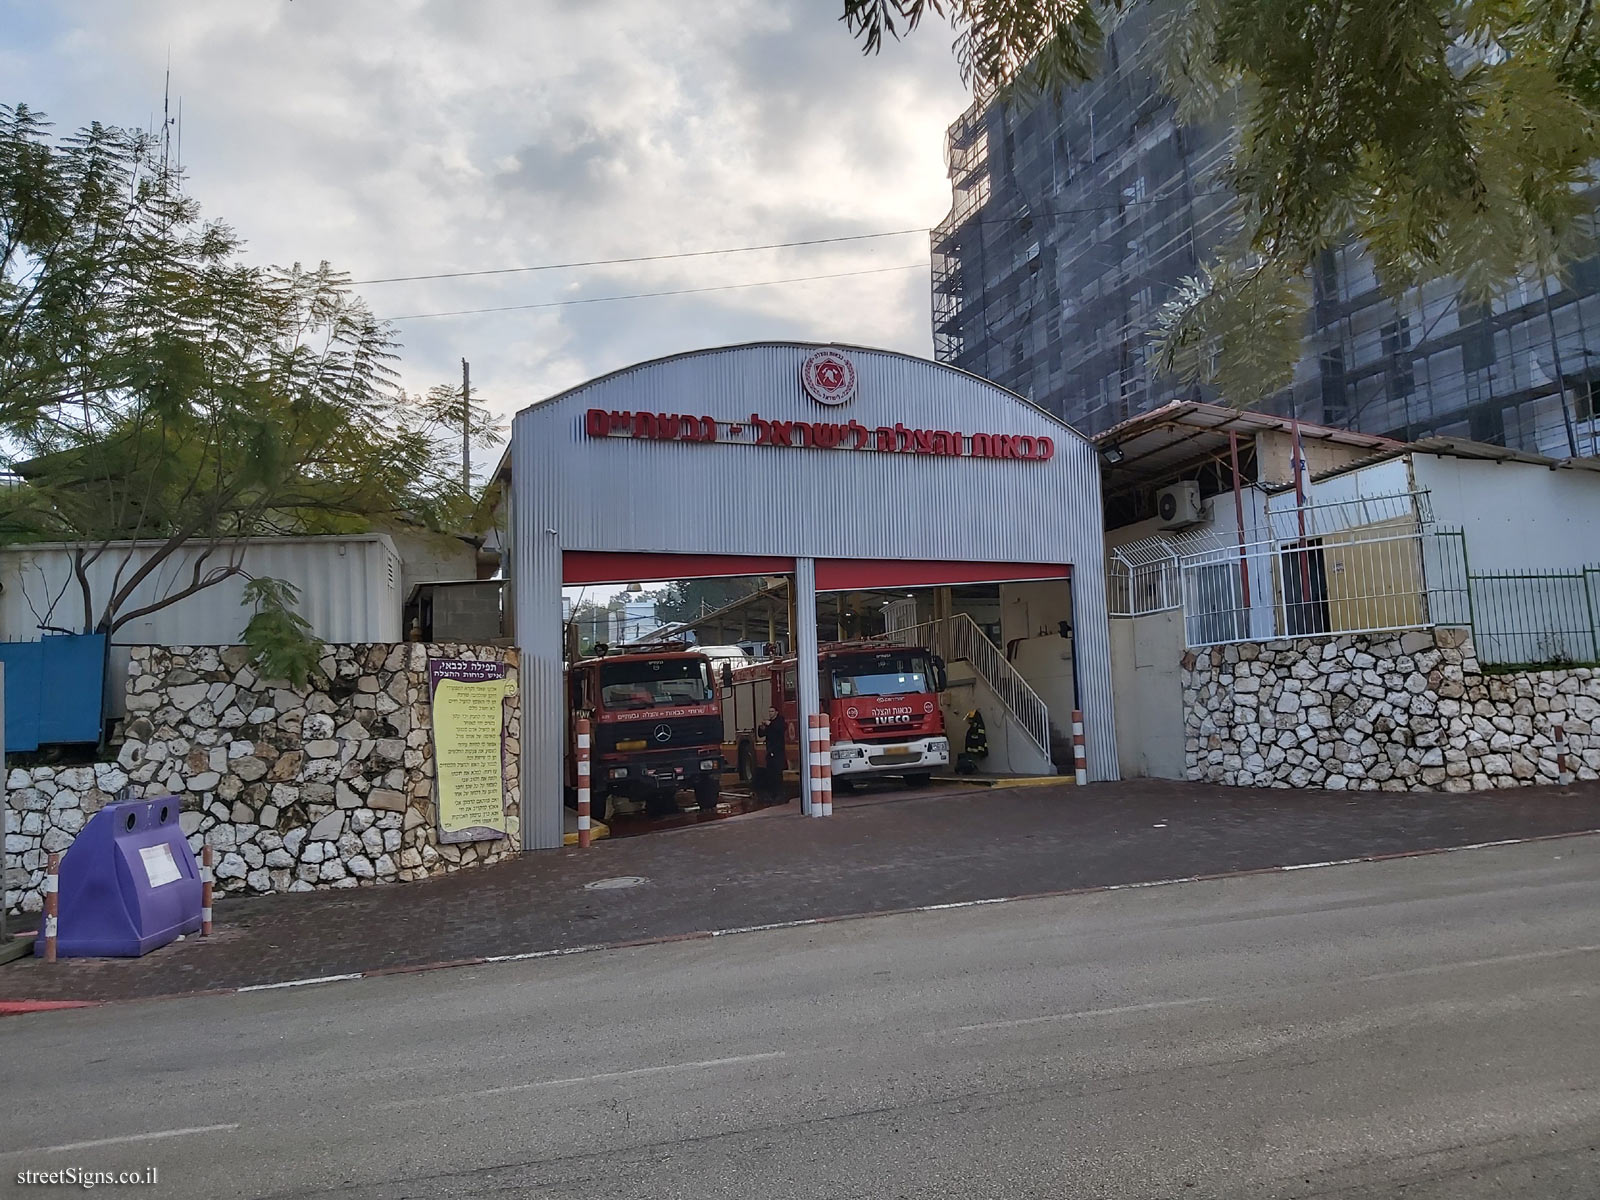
[1098,403,1600,779]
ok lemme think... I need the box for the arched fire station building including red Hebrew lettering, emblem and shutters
[504,342,1117,850]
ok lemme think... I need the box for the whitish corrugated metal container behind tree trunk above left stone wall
[0,533,403,714]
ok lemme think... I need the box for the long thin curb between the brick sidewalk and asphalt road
[0,829,1600,1018]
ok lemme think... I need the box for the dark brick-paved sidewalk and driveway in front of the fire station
[0,781,1600,1000]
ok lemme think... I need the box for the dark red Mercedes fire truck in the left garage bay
[566,643,722,821]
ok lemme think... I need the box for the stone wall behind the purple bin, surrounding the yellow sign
[6,643,522,912]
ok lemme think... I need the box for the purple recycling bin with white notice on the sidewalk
[34,797,200,958]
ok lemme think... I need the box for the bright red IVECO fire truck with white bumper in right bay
[722,642,950,787]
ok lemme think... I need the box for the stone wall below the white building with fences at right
[1182,629,1600,792]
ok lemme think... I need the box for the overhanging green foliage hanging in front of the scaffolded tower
[843,0,1600,405]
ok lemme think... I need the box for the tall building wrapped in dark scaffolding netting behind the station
[933,5,1600,458]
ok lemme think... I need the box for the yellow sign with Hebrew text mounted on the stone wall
[429,659,512,842]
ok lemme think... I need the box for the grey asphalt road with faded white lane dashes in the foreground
[0,837,1600,1200]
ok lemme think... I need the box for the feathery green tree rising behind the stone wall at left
[0,104,499,678]
